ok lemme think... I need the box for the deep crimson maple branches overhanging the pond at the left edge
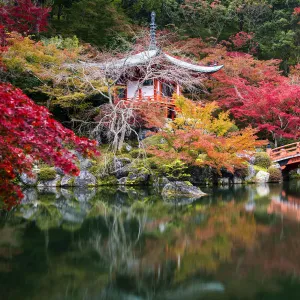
[0,83,98,207]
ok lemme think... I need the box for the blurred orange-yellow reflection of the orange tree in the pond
[165,203,256,281]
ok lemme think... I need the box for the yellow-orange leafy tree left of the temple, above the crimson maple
[1,33,99,108]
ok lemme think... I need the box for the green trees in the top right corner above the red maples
[179,0,300,73]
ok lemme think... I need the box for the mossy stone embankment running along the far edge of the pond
[20,154,282,192]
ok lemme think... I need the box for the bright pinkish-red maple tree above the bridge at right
[219,76,300,146]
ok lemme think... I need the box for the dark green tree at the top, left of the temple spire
[50,0,126,46]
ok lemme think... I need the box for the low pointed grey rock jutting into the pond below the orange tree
[161,181,206,198]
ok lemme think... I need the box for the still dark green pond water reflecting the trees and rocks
[0,181,300,300]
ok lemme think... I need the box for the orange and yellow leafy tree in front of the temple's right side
[148,96,265,172]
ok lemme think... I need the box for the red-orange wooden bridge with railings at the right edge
[267,142,300,171]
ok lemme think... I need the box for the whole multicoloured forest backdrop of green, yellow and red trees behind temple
[0,0,300,145]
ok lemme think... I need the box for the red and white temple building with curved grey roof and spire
[84,12,223,118]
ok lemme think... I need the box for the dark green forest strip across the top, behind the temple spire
[45,0,300,71]
